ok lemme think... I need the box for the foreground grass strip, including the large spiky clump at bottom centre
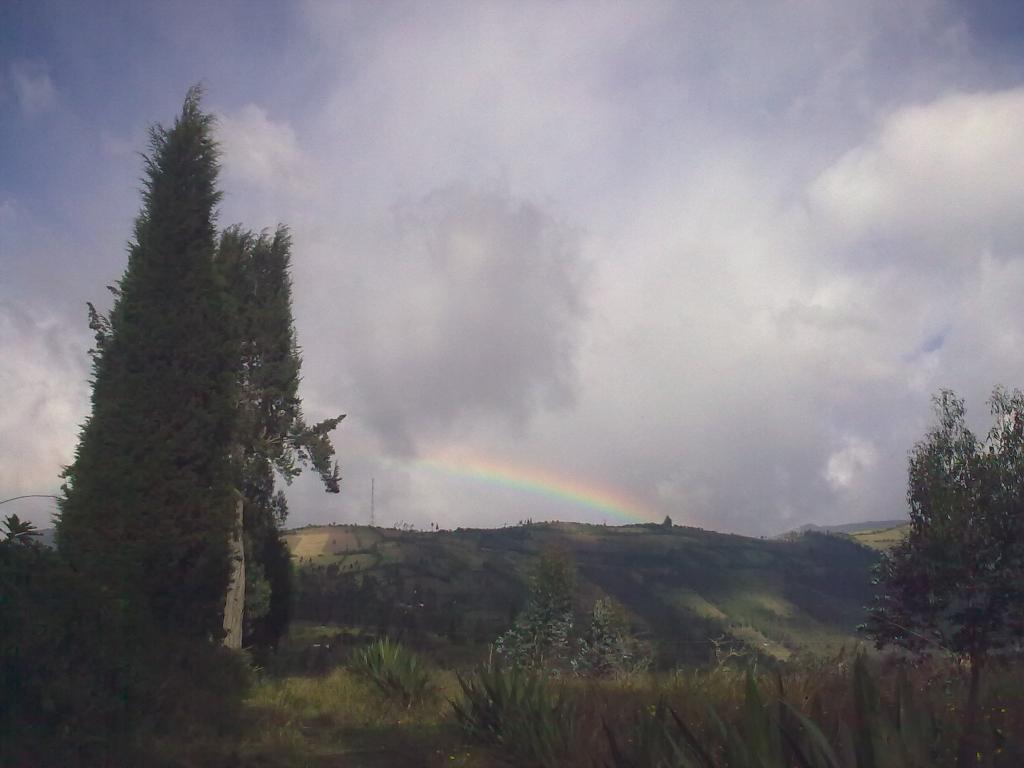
[220,643,1024,768]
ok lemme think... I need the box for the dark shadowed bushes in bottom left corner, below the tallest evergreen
[0,542,248,768]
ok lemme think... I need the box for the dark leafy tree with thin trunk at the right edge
[866,389,1024,765]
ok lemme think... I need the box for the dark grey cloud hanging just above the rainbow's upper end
[345,186,586,453]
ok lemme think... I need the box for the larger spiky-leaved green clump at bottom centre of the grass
[451,665,574,767]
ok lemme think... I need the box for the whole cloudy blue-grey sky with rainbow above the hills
[0,0,1024,536]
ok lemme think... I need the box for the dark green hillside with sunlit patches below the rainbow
[287,523,877,665]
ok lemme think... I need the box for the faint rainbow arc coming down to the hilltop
[416,453,660,523]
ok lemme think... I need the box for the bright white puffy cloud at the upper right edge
[810,88,1024,258]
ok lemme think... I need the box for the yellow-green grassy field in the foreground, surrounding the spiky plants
[209,655,1024,768]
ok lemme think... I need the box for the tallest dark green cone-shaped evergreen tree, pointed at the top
[57,88,238,639]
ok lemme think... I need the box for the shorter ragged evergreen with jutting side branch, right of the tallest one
[217,226,344,647]
